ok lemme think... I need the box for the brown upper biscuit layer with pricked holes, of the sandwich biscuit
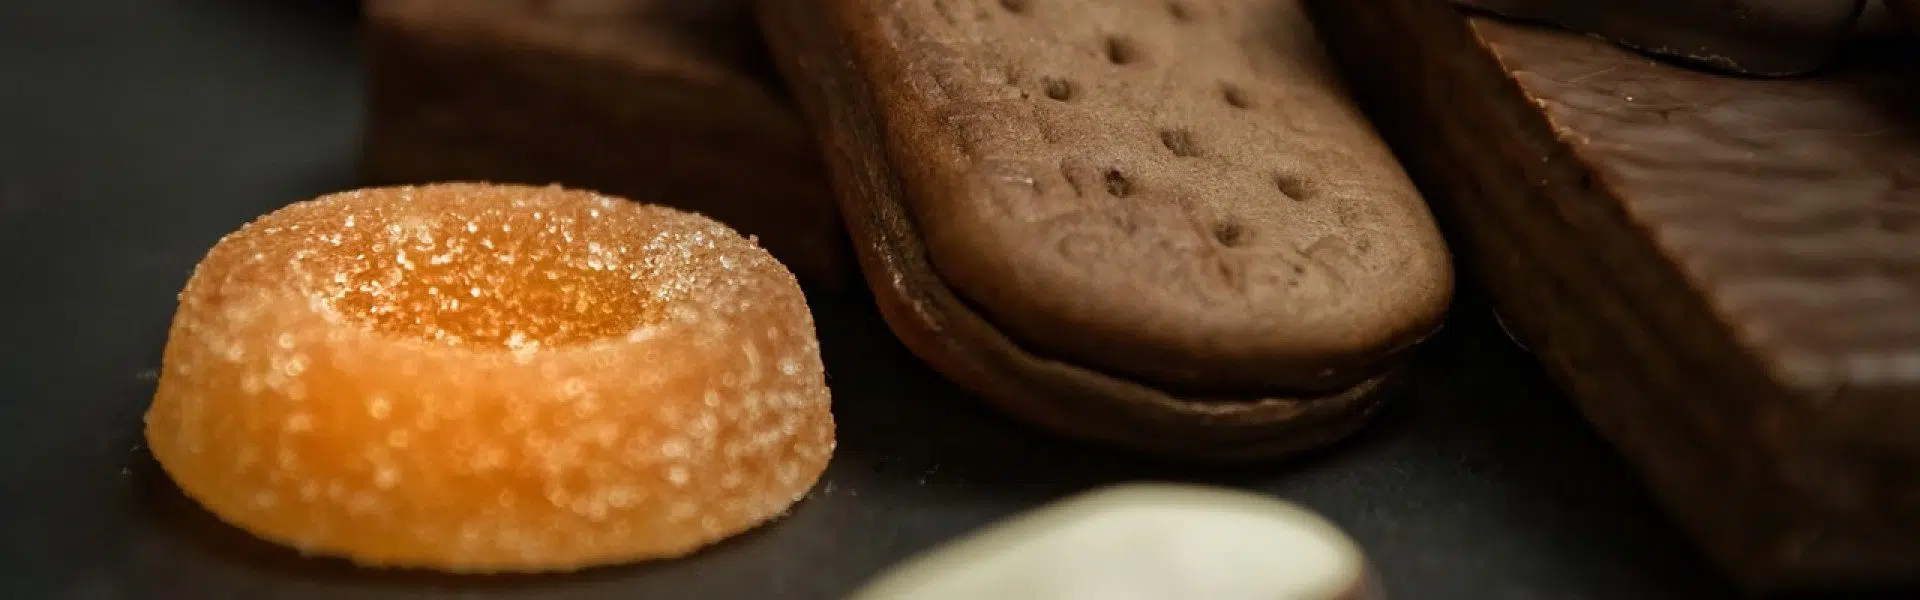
[829,0,1452,392]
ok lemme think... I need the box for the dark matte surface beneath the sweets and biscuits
[0,0,1774,600]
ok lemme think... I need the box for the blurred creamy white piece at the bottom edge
[851,485,1373,600]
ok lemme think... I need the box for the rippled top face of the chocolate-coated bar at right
[1473,21,1920,421]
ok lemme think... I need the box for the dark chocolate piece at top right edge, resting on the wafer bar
[1453,0,1866,77]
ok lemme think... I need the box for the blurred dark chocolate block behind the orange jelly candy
[365,0,854,288]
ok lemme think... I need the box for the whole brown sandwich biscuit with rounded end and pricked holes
[760,0,1452,458]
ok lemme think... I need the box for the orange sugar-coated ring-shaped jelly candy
[146,185,833,571]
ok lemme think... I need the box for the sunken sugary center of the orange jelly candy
[303,194,657,350]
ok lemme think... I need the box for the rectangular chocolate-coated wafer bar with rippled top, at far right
[1309,0,1920,590]
